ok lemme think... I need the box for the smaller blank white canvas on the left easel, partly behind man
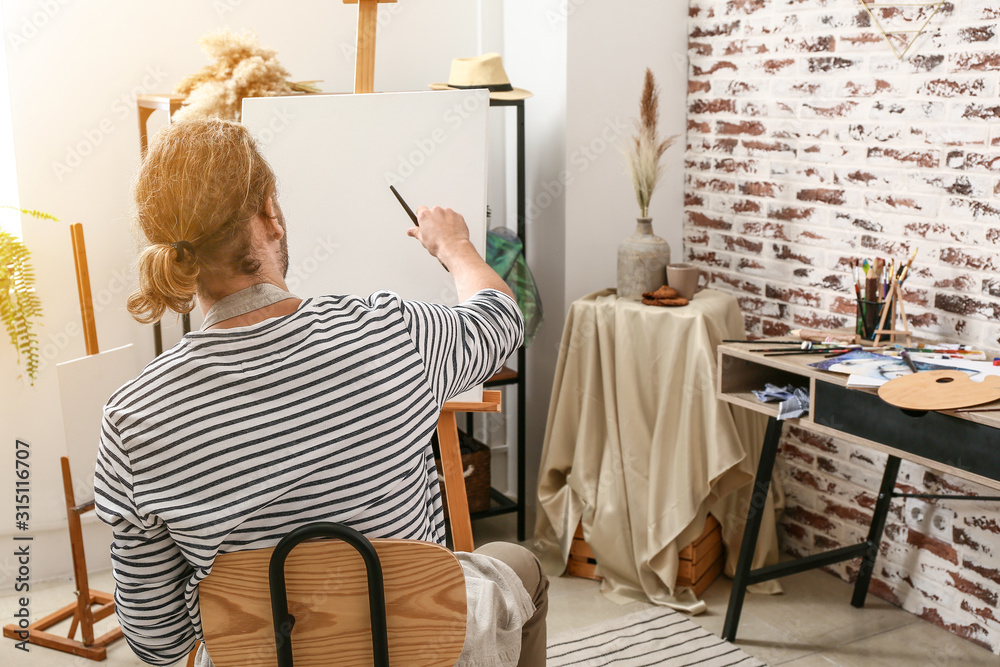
[56,345,141,504]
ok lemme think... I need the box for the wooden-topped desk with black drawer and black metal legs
[718,344,1000,641]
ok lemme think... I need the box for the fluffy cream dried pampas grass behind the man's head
[174,30,318,120]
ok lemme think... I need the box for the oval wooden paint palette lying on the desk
[878,370,1000,410]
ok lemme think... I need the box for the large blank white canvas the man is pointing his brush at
[243,89,489,401]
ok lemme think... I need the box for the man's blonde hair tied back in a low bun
[127,118,276,324]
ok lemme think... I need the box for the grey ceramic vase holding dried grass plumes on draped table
[617,68,678,299]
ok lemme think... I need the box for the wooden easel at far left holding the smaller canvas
[3,223,122,661]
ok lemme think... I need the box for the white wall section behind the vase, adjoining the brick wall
[566,0,688,304]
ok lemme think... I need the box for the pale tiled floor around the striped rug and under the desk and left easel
[0,516,1000,667]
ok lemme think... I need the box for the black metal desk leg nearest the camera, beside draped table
[722,417,782,642]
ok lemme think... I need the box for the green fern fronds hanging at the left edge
[0,206,58,384]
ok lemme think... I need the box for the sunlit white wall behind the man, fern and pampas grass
[0,0,478,586]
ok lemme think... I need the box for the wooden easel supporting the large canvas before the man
[344,0,490,551]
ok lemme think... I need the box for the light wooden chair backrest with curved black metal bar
[199,522,466,667]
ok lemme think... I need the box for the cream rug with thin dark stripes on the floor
[548,607,764,667]
